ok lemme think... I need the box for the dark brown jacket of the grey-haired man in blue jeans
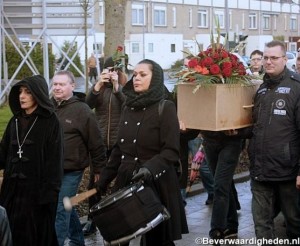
[52,95,106,173]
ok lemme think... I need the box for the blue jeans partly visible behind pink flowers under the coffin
[188,137,214,194]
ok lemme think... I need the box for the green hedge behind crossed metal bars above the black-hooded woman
[5,38,55,79]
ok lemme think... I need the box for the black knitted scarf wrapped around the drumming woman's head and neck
[123,59,165,109]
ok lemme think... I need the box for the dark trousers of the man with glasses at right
[251,179,300,239]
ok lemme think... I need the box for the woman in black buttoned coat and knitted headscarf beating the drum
[98,60,188,246]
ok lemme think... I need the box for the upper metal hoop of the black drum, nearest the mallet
[90,182,144,213]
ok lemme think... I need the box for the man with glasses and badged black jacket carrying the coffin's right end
[249,41,300,242]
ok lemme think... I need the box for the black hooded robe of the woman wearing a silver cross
[0,76,63,246]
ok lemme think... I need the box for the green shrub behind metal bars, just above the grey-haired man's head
[58,41,84,77]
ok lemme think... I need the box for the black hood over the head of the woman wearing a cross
[9,75,54,116]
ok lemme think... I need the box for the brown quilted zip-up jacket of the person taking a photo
[86,83,125,150]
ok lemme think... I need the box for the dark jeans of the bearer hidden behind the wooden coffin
[203,138,242,232]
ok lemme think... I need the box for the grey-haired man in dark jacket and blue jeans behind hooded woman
[52,71,106,246]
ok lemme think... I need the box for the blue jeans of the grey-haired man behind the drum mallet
[55,171,85,246]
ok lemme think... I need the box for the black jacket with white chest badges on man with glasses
[249,68,300,181]
